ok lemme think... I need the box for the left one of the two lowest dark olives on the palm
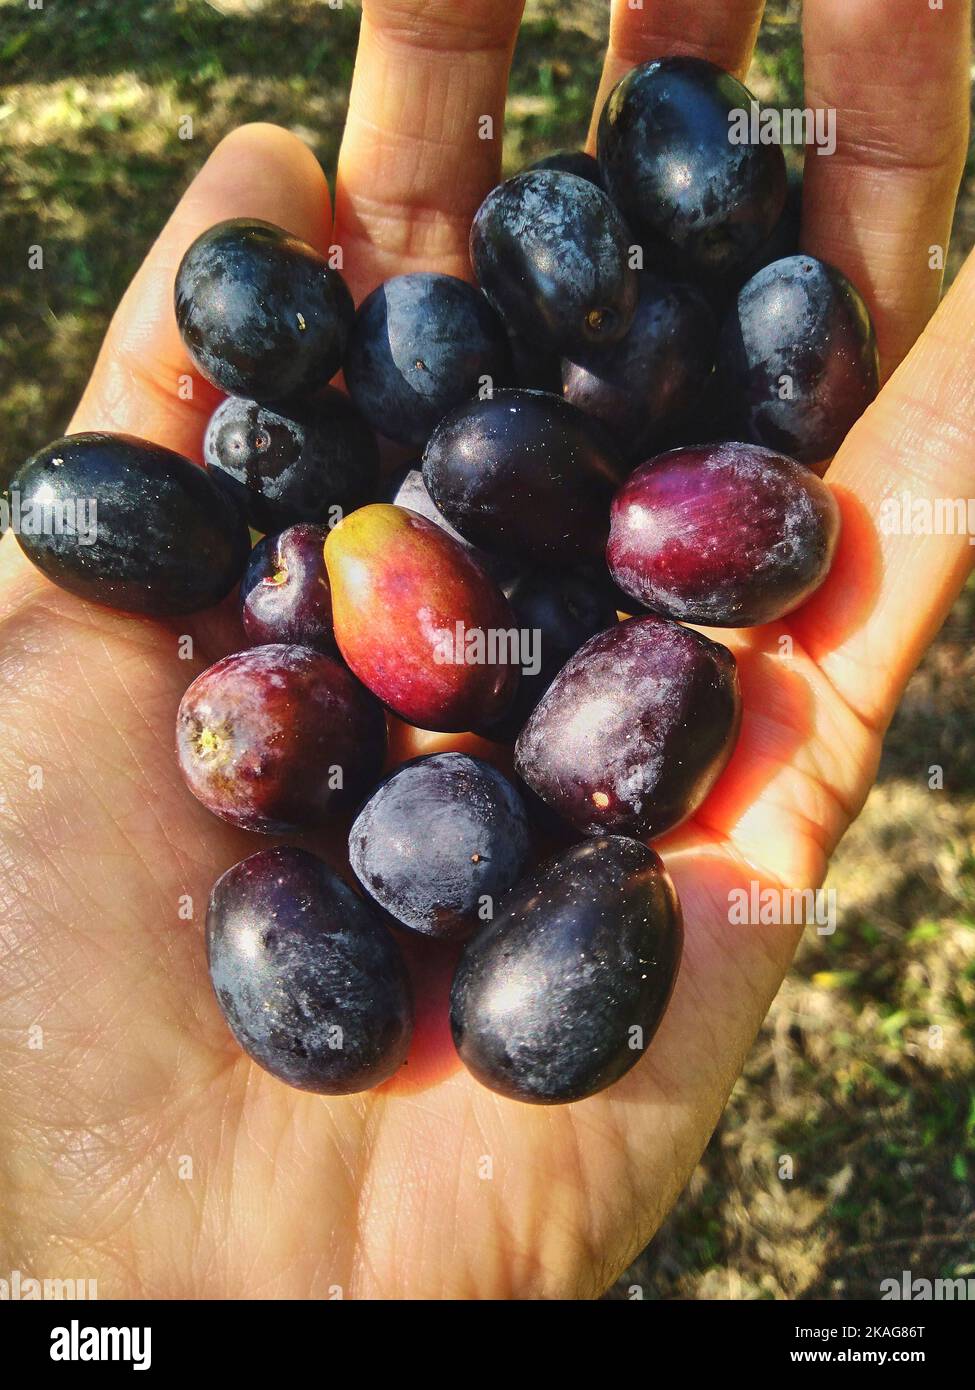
[206,847,413,1095]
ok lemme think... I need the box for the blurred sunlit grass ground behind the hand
[0,0,975,1300]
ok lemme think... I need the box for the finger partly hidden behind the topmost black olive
[588,0,765,150]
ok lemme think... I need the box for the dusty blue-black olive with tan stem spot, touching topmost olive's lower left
[470,170,637,353]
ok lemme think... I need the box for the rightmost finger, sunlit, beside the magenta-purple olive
[791,254,975,727]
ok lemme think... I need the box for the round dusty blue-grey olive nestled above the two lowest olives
[349,753,530,940]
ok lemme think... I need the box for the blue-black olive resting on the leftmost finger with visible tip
[175,217,355,402]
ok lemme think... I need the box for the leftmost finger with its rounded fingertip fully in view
[70,125,330,457]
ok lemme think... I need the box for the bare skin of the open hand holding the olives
[0,0,975,1298]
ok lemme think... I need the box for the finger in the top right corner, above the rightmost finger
[803,0,971,375]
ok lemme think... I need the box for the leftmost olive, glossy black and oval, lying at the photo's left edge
[10,432,250,617]
